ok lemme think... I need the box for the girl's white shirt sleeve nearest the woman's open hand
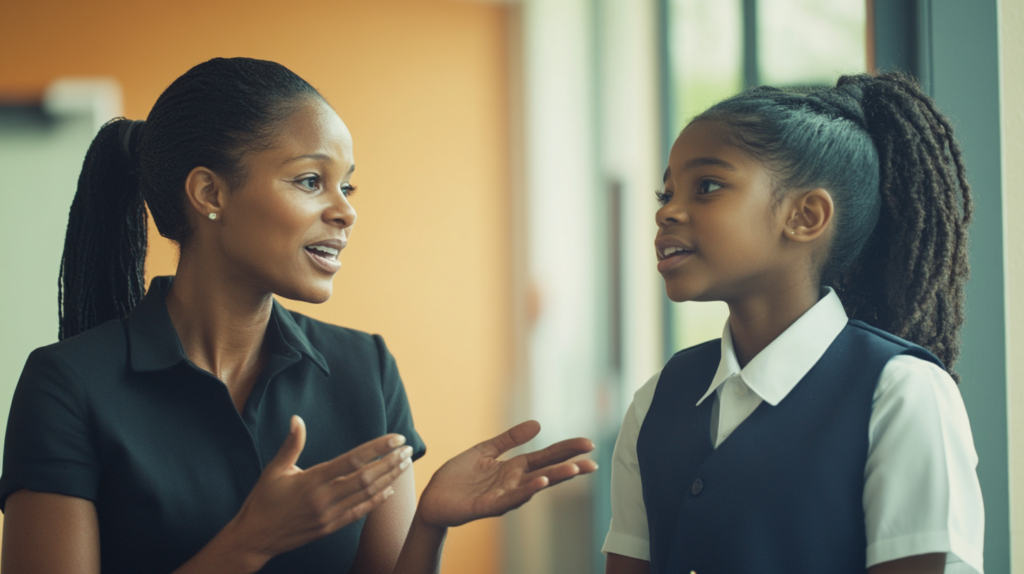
[601,371,662,561]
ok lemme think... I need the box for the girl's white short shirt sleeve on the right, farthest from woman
[863,355,985,574]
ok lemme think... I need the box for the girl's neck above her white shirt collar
[726,274,820,367]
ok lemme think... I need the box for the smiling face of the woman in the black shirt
[211,98,355,303]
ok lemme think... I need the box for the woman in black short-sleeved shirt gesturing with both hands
[0,58,596,574]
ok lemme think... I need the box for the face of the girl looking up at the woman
[654,121,790,303]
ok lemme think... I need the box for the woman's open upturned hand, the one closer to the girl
[418,421,597,528]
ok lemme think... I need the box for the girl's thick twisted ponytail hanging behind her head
[825,74,973,378]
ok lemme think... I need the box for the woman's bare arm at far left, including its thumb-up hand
[0,416,412,574]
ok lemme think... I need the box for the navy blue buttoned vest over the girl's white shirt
[637,321,941,574]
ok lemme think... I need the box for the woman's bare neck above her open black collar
[166,250,273,410]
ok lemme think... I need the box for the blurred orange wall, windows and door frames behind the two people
[0,0,1024,574]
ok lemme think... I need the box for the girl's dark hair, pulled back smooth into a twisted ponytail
[693,73,973,381]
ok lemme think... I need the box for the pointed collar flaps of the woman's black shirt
[128,276,330,376]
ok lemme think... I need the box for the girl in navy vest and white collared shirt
[604,74,984,574]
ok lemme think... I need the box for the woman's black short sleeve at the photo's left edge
[0,348,99,511]
